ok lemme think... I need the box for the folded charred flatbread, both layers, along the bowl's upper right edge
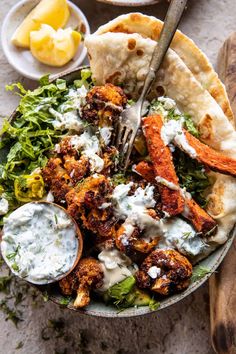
[85,14,236,245]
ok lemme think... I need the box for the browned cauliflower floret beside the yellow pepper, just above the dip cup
[42,157,71,203]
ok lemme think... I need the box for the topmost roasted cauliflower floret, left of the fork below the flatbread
[82,84,127,127]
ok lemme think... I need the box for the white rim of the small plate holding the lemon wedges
[0,0,91,80]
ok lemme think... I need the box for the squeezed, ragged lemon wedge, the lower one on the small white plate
[30,25,81,67]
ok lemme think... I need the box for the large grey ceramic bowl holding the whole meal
[4,67,236,317]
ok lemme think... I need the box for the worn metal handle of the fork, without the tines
[140,0,188,101]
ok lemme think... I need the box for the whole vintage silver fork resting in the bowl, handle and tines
[115,0,188,172]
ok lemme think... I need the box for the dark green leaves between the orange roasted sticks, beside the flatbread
[173,149,210,208]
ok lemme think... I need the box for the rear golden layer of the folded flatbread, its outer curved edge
[95,13,234,125]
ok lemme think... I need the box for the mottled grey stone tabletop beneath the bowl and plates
[0,0,236,354]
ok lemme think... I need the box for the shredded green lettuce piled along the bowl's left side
[0,69,91,210]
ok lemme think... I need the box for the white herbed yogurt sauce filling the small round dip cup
[1,203,79,284]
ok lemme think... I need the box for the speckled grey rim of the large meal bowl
[4,65,236,318]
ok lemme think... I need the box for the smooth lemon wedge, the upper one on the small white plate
[11,0,70,48]
